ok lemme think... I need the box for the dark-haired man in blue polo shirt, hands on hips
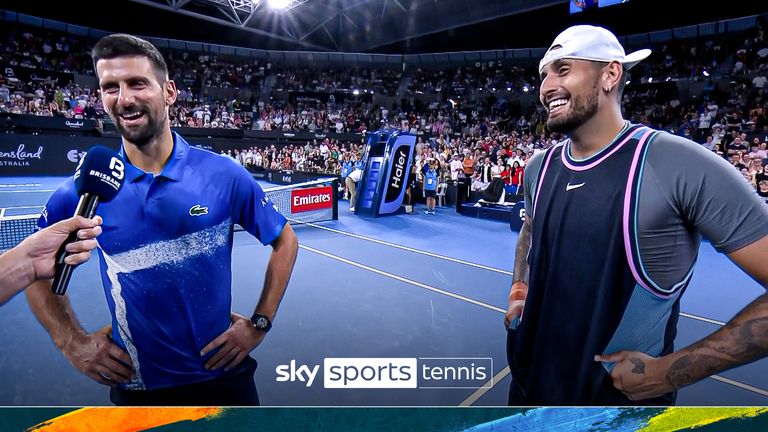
[27,34,298,405]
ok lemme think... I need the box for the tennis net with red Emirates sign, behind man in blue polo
[0,178,339,251]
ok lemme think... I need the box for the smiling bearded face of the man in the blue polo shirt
[96,55,176,147]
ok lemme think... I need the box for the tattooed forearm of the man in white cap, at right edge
[667,294,768,388]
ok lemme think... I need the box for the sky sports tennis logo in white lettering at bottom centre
[275,357,493,389]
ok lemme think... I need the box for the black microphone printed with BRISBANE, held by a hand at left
[52,146,125,295]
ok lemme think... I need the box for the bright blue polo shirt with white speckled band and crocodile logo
[38,133,286,390]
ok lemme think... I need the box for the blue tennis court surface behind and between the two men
[0,177,768,406]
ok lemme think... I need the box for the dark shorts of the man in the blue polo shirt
[109,356,259,406]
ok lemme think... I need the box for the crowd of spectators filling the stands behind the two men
[0,17,768,199]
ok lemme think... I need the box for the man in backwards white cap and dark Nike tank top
[505,26,768,405]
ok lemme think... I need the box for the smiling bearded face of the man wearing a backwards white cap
[539,59,602,133]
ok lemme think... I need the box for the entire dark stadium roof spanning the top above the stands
[0,0,768,56]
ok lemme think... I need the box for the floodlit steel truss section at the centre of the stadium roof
[130,0,563,52]
